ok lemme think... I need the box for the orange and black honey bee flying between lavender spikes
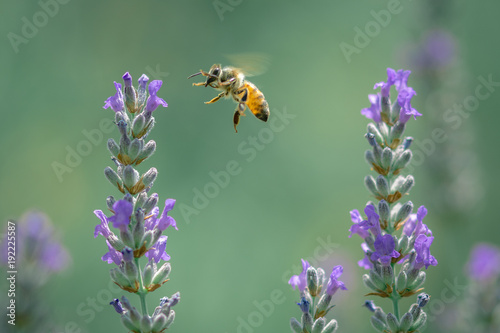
[188,64,269,133]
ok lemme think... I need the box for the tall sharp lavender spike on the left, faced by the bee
[94,72,180,333]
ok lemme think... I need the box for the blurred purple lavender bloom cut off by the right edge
[466,243,500,282]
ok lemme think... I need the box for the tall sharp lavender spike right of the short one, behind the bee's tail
[349,68,438,333]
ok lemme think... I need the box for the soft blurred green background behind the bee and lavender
[0,0,500,333]
